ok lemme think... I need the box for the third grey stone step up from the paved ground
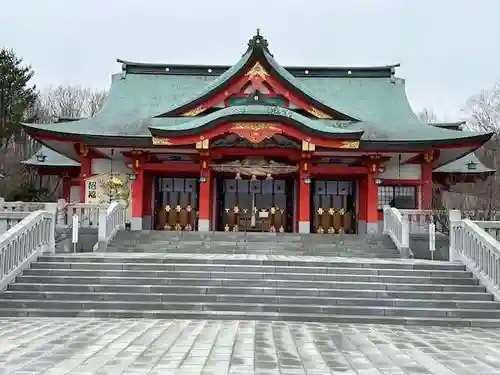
[0,291,500,310]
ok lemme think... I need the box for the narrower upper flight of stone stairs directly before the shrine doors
[107,231,400,259]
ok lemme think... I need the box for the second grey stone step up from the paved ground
[1,299,500,320]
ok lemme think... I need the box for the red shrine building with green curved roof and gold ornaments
[23,33,493,233]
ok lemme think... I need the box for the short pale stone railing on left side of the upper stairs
[94,202,125,251]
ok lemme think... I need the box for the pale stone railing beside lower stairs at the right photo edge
[450,210,500,301]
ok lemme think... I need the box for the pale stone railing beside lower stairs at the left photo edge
[0,210,55,290]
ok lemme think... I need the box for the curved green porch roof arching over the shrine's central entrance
[150,105,362,138]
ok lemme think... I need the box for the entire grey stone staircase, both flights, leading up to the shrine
[0,233,500,326]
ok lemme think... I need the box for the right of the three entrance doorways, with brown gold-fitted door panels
[311,180,357,233]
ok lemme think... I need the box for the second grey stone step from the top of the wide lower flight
[31,261,473,278]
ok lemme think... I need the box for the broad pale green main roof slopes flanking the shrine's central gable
[20,31,489,150]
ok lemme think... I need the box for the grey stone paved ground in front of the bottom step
[0,318,500,375]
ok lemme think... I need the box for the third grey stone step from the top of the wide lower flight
[21,269,478,285]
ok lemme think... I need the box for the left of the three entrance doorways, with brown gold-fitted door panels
[154,177,198,231]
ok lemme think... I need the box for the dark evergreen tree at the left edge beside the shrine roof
[0,48,38,148]
